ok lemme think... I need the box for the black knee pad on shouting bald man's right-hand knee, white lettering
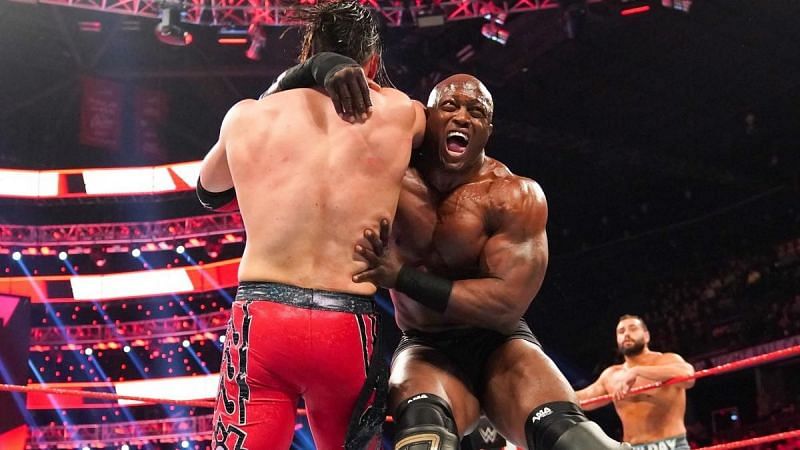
[525,402,630,450]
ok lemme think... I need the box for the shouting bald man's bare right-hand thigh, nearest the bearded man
[481,339,576,446]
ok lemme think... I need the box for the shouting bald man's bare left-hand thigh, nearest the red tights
[389,346,480,436]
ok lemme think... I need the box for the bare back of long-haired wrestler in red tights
[226,88,415,295]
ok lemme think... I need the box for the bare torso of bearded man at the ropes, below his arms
[606,366,686,444]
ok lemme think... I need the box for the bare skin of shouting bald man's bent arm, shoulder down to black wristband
[444,181,548,332]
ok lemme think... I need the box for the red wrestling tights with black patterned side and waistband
[212,285,377,450]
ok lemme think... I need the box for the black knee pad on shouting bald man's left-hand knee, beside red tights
[394,393,458,450]
